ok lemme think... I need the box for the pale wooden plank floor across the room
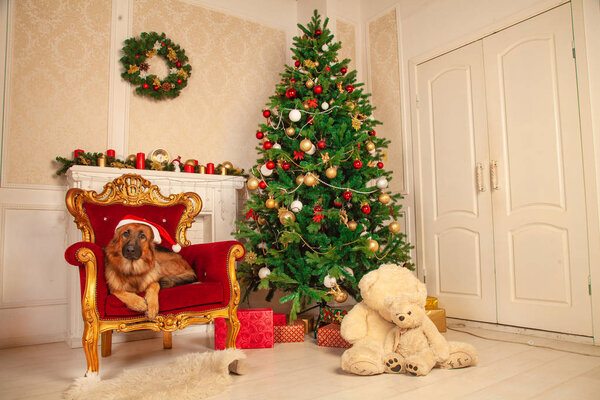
[0,328,600,400]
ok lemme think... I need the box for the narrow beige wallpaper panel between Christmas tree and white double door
[369,10,404,192]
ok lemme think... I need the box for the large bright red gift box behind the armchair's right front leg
[215,308,273,350]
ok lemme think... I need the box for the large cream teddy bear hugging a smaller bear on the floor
[340,264,477,375]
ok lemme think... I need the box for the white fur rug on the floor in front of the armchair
[64,349,246,400]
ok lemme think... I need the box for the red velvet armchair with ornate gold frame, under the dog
[65,174,244,375]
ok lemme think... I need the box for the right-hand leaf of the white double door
[483,4,592,335]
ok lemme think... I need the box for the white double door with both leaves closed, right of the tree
[415,4,592,335]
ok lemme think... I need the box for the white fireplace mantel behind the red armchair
[65,165,245,347]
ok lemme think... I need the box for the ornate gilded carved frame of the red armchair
[66,174,244,376]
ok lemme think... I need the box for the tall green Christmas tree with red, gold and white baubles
[235,10,412,320]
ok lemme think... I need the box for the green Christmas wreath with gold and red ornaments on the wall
[121,32,192,100]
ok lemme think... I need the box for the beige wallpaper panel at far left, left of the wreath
[2,0,111,185]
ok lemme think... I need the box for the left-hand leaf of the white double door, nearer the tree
[417,42,496,322]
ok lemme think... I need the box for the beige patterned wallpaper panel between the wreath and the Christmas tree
[129,0,286,170]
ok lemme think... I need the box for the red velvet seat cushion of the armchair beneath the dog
[103,282,229,318]
